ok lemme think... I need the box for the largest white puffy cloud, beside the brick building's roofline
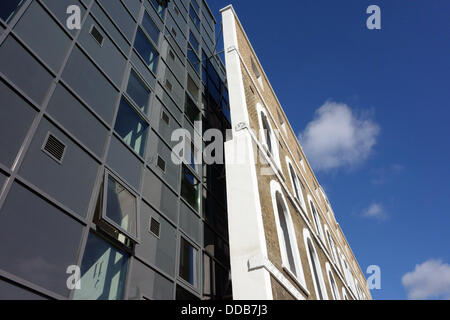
[299,101,380,170]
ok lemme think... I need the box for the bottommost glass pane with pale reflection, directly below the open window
[73,233,128,300]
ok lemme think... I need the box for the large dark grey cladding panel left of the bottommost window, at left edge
[0,184,82,297]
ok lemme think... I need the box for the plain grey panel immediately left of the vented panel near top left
[14,2,71,72]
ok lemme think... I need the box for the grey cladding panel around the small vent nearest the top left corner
[79,14,126,87]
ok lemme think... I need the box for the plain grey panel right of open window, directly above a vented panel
[142,169,180,224]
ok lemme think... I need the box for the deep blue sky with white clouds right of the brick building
[208,0,450,299]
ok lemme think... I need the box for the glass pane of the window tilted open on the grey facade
[106,175,137,236]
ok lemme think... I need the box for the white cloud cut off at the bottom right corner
[402,259,450,299]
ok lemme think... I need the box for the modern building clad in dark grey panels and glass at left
[0,0,232,299]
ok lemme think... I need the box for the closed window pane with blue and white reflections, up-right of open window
[114,99,148,157]
